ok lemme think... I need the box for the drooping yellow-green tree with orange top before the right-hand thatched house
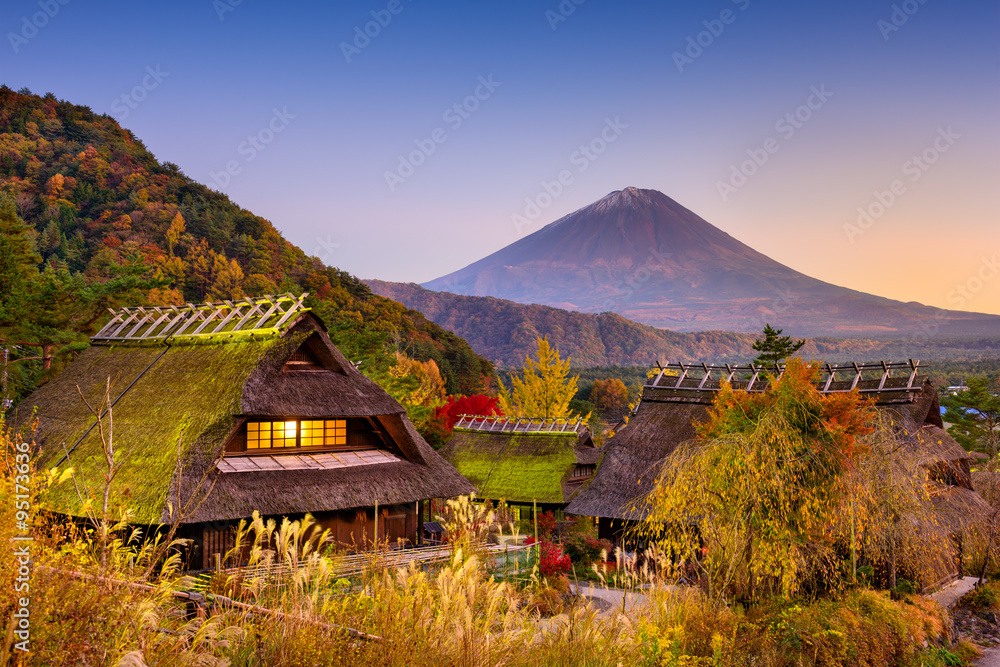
[643,359,873,599]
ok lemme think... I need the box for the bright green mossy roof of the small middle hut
[441,428,600,504]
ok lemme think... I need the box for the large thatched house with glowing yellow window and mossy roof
[15,295,472,563]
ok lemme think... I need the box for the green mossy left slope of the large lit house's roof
[22,336,283,523]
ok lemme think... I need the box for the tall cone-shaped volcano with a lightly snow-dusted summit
[423,188,1000,337]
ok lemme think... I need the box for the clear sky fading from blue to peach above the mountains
[0,0,1000,313]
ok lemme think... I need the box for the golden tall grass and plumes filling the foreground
[0,422,968,667]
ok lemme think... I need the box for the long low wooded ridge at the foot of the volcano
[365,280,1000,368]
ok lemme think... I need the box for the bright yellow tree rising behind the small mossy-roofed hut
[500,338,579,419]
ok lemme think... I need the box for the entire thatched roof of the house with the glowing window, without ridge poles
[13,298,472,524]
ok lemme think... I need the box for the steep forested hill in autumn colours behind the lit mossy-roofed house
[0,86,492,408]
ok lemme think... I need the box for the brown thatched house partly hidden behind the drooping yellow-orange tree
[566,361,972,537]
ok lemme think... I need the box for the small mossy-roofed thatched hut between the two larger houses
[441,416,600,520]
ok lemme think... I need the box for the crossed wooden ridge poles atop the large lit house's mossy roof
[90,292,310,342]
